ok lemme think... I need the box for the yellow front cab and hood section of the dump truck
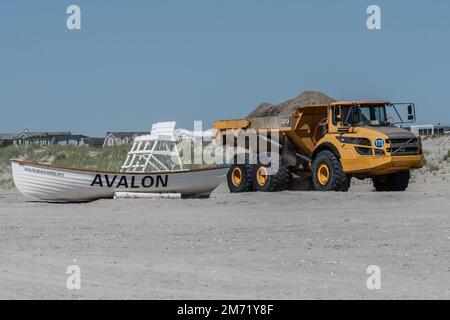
[312,101,423,191]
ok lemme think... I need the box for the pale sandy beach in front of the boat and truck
[0,155,450,299]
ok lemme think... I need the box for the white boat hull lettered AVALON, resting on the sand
[11,160,228,201]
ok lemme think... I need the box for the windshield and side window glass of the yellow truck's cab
[341,104,389,126]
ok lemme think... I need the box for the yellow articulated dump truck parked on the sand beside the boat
[214,101,423,192]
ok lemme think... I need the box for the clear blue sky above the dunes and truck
[0,0,450,136]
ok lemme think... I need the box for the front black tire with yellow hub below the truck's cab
[311,150,351,192]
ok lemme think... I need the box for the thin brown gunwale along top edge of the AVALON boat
[10,159,229,176]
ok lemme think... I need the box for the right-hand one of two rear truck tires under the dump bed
[252,164,290,192]
